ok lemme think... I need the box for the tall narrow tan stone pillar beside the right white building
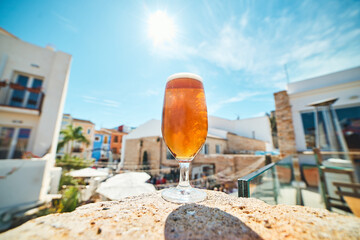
[274,91,296,157]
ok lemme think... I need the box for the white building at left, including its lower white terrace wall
[0,28,71,220]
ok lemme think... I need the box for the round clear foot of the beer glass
[161,187,206,203]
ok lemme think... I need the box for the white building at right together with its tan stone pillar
[274,67,360,156]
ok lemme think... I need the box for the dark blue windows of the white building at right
[301,106,360,150]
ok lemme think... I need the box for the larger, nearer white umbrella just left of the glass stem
[96,172,156,200]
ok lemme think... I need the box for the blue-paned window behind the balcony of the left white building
[9,74,43,109]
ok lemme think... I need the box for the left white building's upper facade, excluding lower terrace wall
[0,27,71,159]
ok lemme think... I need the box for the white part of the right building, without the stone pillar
[287,67,360,151]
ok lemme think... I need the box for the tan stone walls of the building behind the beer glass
[123,134,265,177]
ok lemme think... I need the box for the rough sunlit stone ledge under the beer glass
[0,191,360,239]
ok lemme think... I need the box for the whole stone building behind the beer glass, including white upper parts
[120,116,272,178]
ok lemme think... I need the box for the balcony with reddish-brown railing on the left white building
[0,81,45,115]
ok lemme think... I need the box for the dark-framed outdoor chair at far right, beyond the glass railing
[313,148,360,214]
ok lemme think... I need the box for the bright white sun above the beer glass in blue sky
[148,10,176,45]
